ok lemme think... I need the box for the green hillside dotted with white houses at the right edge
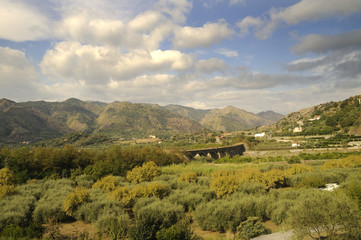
[275,95,361,135]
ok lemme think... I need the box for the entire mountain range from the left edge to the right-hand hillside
[0,98,283,143]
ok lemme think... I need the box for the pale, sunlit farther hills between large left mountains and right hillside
[164,105,283,132]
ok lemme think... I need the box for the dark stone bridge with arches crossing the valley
[184,144,246,159]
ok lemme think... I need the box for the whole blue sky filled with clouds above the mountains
[0,0,361,114]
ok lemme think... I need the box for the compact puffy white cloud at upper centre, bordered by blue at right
[173,20,234,49]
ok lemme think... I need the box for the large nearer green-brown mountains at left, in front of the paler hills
[0,98,205,143]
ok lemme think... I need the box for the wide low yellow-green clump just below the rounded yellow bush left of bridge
[109,182,170,207]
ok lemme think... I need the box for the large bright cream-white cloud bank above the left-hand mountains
[41,41,193,84]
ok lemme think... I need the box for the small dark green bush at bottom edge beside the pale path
[237,217,271,240]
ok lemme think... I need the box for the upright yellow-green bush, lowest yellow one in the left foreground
[63,188,90,216]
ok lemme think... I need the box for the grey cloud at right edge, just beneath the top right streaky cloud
[292,29,361,54]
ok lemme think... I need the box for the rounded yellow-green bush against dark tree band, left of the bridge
[127,161,159,183]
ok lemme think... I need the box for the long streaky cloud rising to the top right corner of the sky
[239,0,361,39]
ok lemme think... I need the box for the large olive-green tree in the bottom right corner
[287,190,360,239]
